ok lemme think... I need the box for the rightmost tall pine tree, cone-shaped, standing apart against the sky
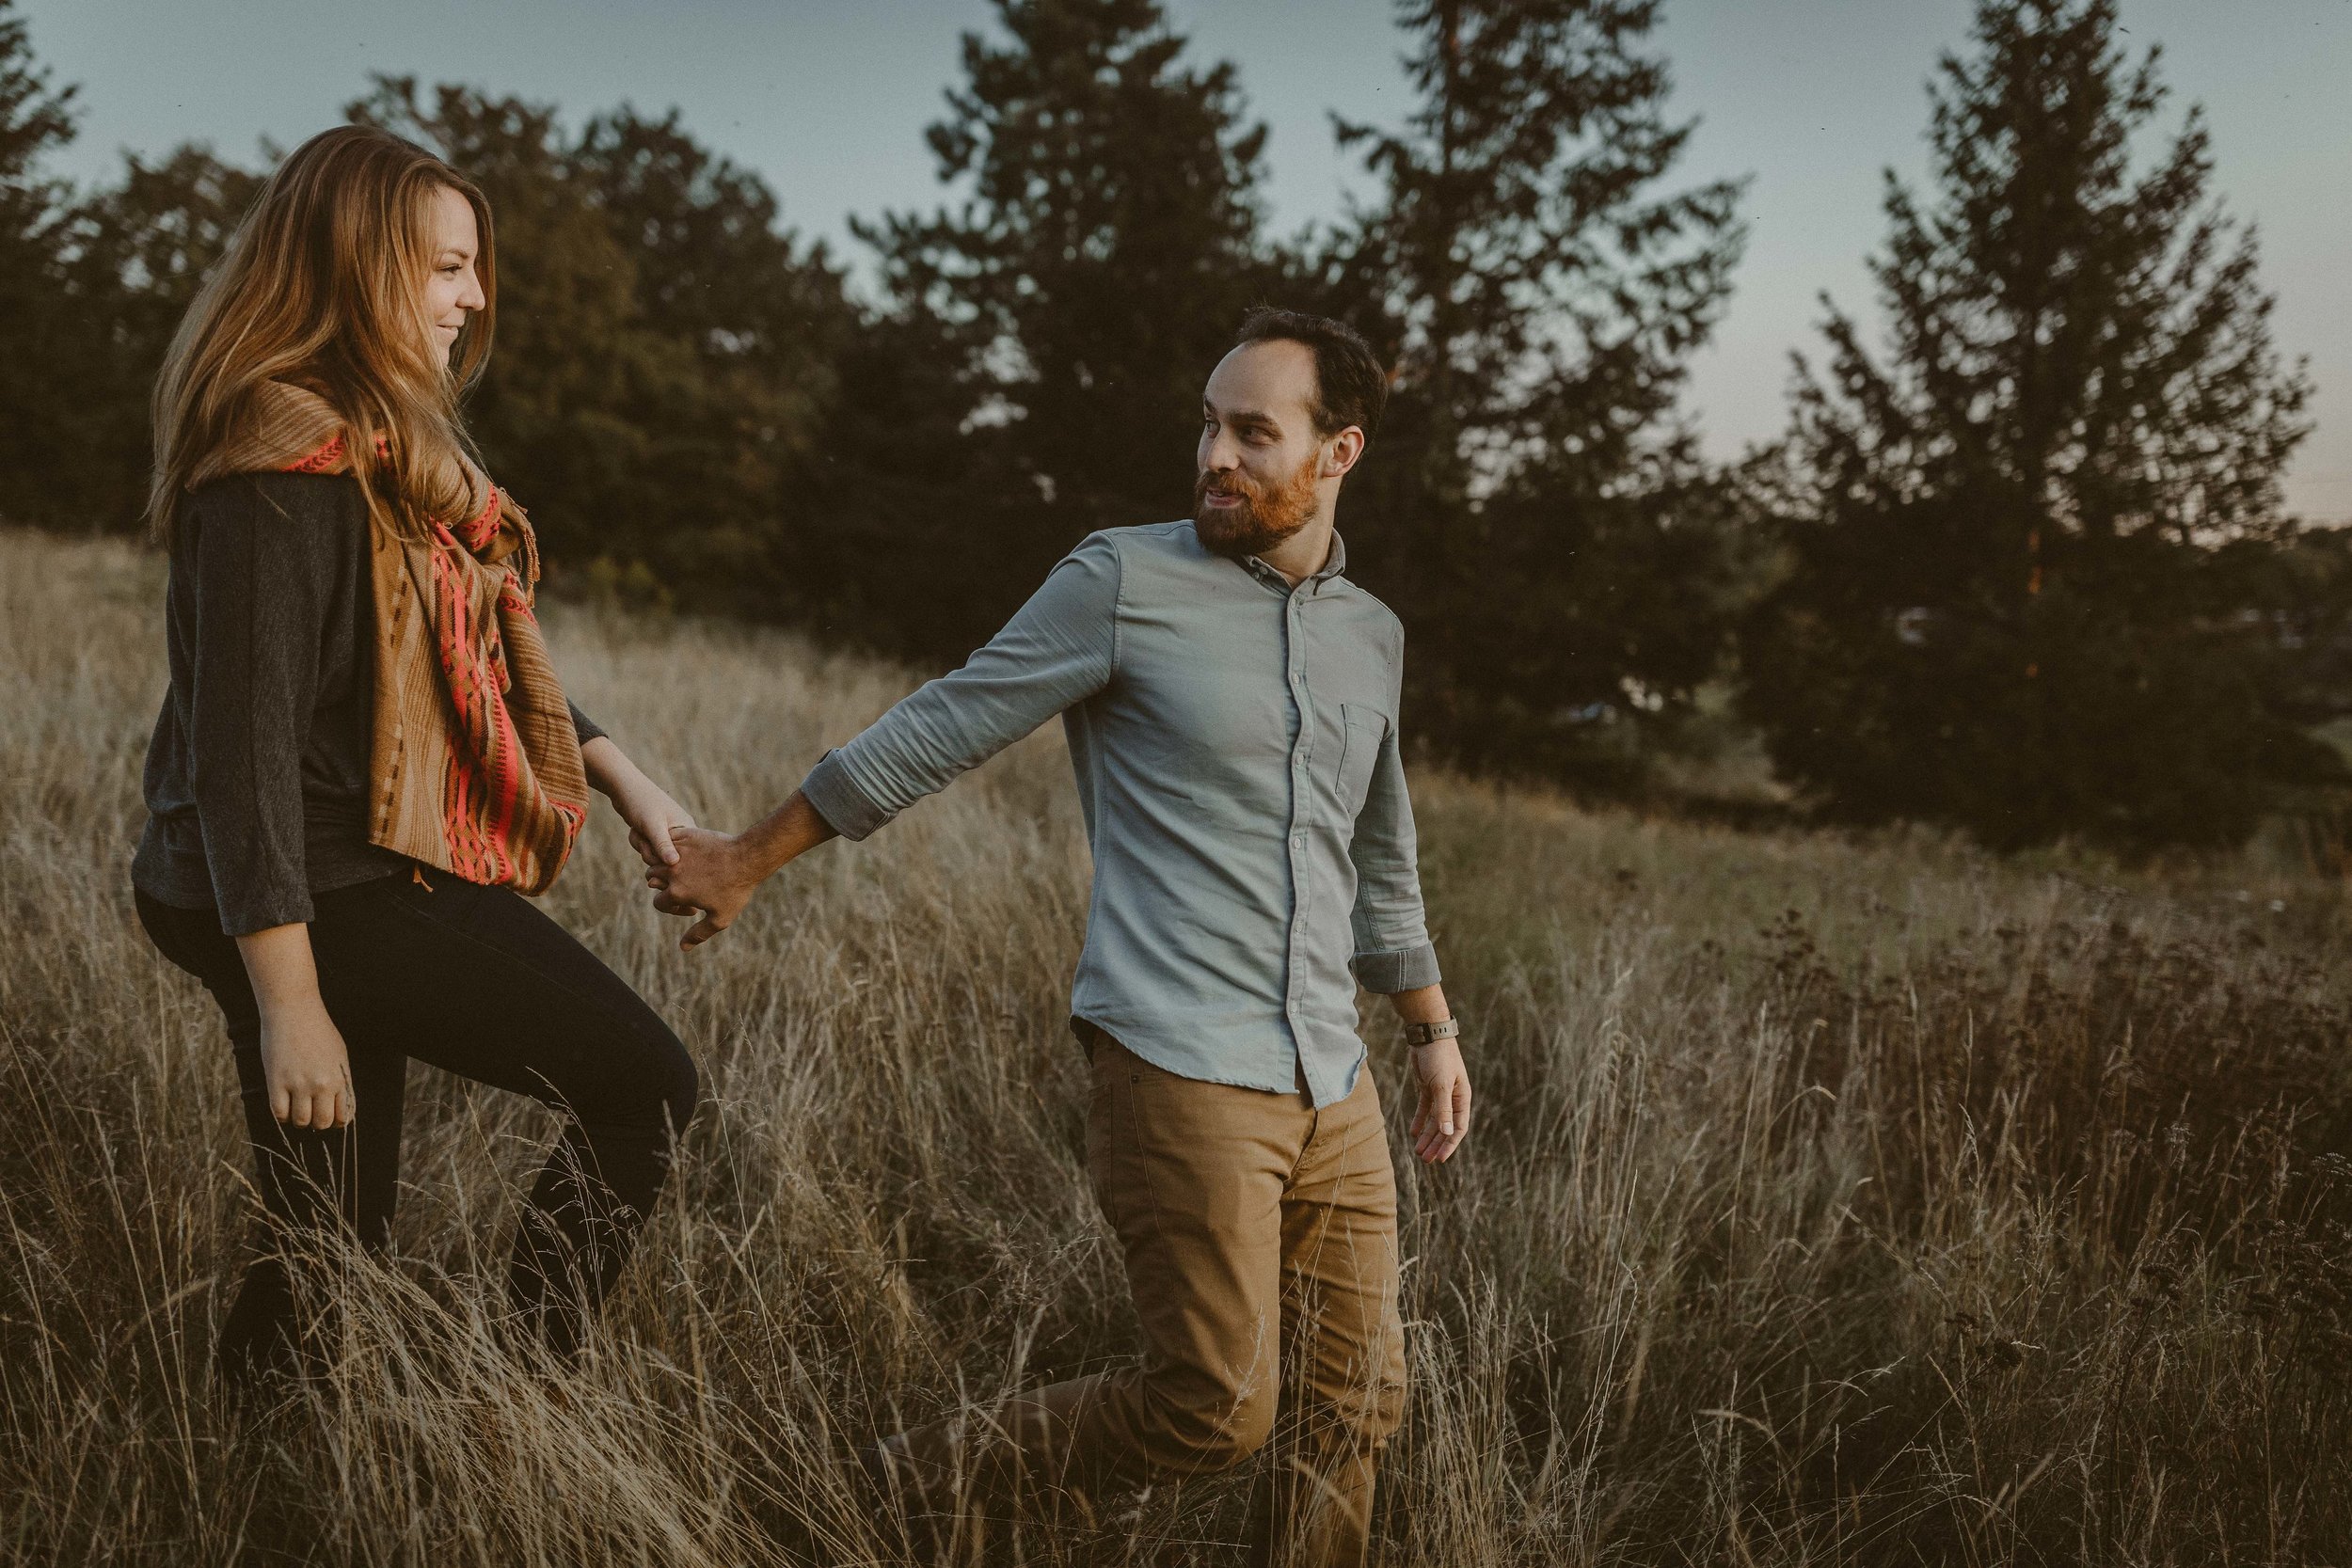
[1743,0,2336,847]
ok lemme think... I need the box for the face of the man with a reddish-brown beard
[1193,341,1327,560]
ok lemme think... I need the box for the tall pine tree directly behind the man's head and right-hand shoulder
[1325,0,1740,781]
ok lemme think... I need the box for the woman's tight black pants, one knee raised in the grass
[139,870,696,1378]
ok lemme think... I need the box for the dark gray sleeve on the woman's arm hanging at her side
[188,483,334,936]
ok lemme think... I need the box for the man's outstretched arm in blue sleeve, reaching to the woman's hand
[644,533,1120,947]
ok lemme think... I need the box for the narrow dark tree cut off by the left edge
[0,0,87,524]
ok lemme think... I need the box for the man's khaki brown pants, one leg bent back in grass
[892,1025,1405,1568]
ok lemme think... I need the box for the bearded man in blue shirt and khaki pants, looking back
[649,310,1470,1563]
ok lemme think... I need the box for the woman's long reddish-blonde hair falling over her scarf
[149,124,499,536]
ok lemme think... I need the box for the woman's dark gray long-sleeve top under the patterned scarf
[132,475,602,936]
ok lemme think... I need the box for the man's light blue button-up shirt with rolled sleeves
[803,522,1438,1105]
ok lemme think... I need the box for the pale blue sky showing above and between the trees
[19,0,2352,519]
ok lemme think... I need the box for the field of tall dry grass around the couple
[0,533,2352,1568]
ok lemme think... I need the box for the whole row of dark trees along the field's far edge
[0,0,2352,848]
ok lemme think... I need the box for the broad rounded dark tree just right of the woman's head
[351,77,851,616]
